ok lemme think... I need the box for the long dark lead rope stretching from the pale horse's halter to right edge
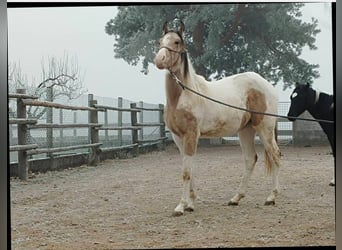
[169,69,335,123]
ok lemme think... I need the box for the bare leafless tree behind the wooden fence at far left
[8,54,86,119]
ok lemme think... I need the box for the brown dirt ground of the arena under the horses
[10,145,335,250]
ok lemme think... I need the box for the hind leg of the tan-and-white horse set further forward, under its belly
[228,126,258,206]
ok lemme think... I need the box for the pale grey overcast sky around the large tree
[8,3,333,104]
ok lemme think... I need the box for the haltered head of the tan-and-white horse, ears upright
[154,19,187,72]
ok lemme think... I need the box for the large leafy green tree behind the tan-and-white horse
[105,3,320,89]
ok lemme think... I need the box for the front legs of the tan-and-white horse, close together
[173,132,198,216]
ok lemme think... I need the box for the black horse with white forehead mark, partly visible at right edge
[287,83,336,186]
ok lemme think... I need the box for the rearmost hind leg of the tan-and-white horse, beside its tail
[258,124,280,205]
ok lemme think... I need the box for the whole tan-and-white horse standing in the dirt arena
[155,22,280,216]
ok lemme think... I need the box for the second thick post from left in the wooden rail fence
[88,94,101,166]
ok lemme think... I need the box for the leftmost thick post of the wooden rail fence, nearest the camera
[16,89,28,181]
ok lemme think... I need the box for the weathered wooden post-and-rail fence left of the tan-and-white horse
[8,89,167,180]
